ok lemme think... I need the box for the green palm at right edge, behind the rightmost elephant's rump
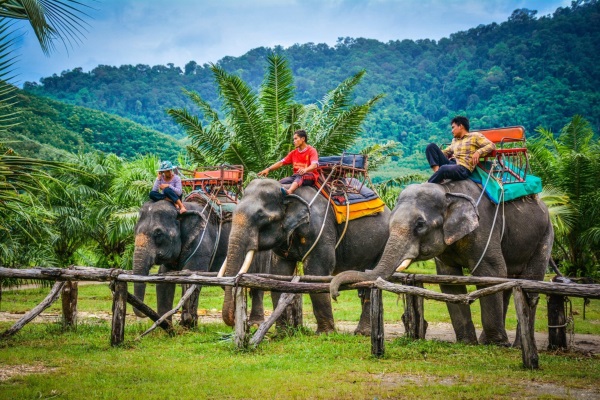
[529,115,600,276]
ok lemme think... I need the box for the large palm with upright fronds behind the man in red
[168,54,382,178]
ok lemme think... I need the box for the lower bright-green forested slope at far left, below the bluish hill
[0,91,184,160]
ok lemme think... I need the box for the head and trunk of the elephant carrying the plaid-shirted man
[330,183,479,299]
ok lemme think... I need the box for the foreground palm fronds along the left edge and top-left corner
[0,0,87,265]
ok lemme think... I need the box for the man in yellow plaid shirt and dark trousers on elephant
[425,116,496,183]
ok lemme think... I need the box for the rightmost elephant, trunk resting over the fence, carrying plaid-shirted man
[330,180,554,346]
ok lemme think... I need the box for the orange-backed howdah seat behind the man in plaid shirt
[473,126,530,184]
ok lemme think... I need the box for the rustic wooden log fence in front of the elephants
[0,266,600,368]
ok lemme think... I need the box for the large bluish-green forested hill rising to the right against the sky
[25,0,600,159]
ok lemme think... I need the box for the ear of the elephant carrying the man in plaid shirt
[444,193,479,245]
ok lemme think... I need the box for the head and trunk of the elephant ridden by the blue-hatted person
[133,201,206,316]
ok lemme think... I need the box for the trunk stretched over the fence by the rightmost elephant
[329,234,417,300]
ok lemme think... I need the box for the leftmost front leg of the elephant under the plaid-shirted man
[435,259,477,344]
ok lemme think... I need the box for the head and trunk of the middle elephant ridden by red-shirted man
[222,179,310,326]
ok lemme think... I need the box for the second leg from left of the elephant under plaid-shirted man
[477,286,508,346]
